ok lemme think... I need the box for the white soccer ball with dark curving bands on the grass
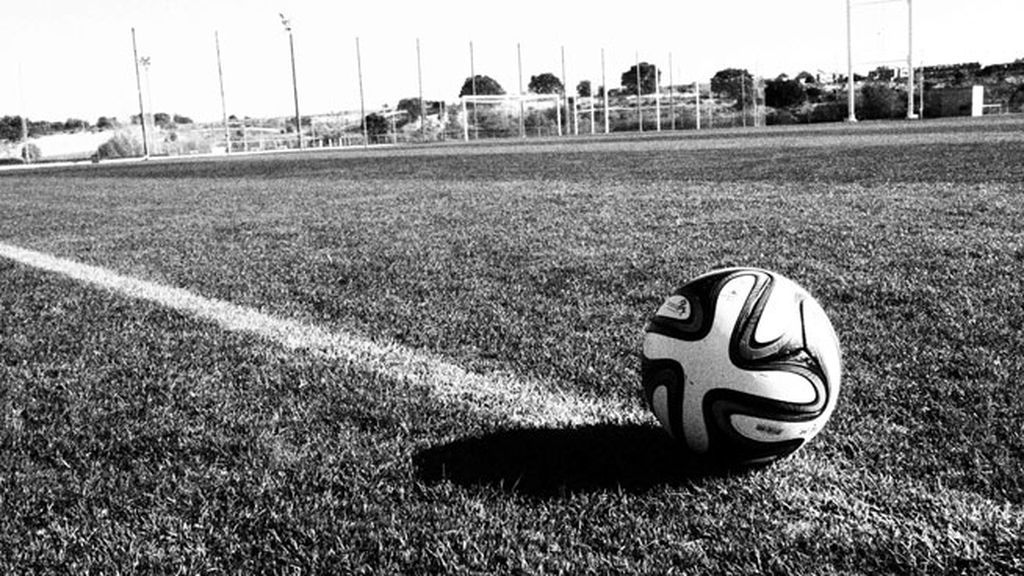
[641,268,841,465]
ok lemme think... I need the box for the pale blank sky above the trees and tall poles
[0,0,1024,123]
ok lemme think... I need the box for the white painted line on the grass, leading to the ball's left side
[0,242,652,426]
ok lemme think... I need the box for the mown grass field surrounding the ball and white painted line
[0,118,1024,574]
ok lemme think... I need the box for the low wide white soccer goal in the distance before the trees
[459,94,562,141]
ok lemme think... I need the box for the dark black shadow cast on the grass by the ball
[413,424,743,496]
